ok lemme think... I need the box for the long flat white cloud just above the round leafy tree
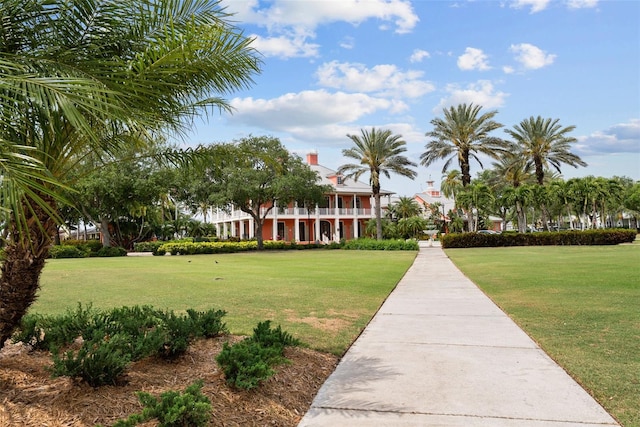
[229,90,407,132]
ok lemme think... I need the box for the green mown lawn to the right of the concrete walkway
[446,244,640,427]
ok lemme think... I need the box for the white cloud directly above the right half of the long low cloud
[316,61,435,98]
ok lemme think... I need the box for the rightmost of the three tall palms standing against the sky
[505,116,587,185]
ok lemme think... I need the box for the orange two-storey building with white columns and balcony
[211,153,393,243]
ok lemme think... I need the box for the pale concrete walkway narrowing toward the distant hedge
[299,243,618,427]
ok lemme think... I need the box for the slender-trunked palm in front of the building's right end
[338,127,417,240]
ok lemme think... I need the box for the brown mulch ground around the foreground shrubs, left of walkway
[0,336,338,427]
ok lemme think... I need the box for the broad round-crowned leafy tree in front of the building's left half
[213,136,330,250]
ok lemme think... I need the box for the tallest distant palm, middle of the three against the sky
[420,104,506,187]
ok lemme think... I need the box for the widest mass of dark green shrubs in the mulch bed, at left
[13,304,227,387]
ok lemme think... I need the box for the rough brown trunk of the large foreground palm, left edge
[0,197,56,348]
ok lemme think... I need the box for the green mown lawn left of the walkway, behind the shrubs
[36,250,416,355]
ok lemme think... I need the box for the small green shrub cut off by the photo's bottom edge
[113,380,211,427]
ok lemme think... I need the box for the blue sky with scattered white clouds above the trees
[184,0,640,196]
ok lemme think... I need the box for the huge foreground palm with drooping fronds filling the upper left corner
[0,0,260,346]
